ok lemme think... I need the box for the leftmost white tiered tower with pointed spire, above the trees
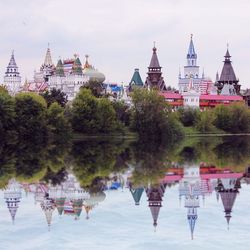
[4,51,22,95]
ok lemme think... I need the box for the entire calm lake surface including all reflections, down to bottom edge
[0,137,250,250]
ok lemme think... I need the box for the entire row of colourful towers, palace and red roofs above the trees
[3,35,250,107]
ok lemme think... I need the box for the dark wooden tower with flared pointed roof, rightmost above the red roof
[217,48,240,95]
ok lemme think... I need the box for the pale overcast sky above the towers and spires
[0,0,250,88]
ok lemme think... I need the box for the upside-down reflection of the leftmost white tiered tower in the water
[4,179,22,224]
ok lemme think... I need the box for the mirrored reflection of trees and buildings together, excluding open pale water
[0,138,250,245]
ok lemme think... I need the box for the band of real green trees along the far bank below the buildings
[0,88,250,146]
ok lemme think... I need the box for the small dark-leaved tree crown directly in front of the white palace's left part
[41,88,68,107]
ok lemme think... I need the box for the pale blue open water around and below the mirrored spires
[0,184,250,250]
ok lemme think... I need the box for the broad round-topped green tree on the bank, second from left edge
[15,93,47,143]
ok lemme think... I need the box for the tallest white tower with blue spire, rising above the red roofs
[178,34,205,93]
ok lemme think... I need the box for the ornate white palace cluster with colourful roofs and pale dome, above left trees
[23,48,105,101]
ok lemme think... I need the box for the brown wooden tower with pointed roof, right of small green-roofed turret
[145,43,166,91]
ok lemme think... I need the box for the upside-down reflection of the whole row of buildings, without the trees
[0,164,246,239]
